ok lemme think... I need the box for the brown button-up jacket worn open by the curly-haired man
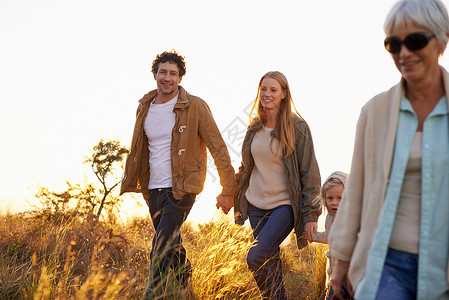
[120,86,236,200]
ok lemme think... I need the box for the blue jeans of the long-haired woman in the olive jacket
[247,203,294,299]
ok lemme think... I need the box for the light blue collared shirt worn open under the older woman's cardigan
[355,95,449,300]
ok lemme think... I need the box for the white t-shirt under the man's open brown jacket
[144,95,178,189]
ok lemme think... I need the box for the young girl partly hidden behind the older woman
[312,171,348,300]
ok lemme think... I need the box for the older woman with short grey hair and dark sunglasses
[329,0,449,300]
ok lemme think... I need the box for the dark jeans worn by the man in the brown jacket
[148,188,196,291]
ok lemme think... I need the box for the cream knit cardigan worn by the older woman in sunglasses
[329,68,449,287]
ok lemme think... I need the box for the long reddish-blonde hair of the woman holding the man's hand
[249,71,303,157]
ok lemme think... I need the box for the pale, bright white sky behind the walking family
[0,0,449,222]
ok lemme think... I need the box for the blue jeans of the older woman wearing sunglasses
[376,248,418,300]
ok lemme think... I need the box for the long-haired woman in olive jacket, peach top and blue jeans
[229,72,321,299]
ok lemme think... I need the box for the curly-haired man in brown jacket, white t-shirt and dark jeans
[120,51,236,298]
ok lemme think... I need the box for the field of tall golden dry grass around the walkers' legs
[0,212,327,299]
